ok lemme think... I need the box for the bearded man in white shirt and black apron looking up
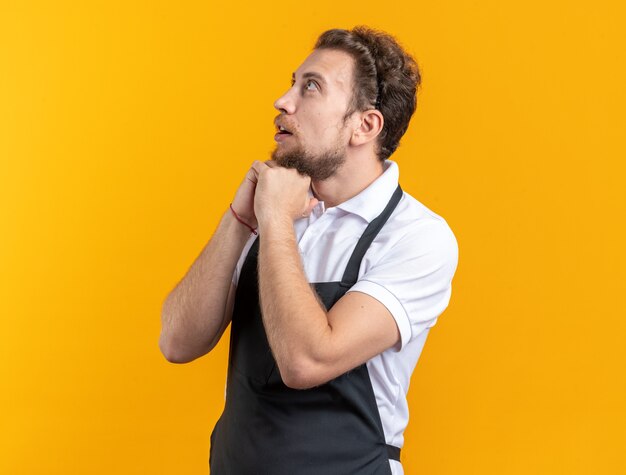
[159,27,458,475]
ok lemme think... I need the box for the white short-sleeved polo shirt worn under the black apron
[233,160,458,475]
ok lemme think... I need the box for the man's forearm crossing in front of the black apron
[259,216,331,382]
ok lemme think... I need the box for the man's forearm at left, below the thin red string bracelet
[159,210,250,362]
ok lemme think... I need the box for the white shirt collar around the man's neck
[309,160,400,223]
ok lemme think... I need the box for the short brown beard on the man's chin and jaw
[272,139,346,181]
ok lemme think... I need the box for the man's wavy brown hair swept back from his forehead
[314,26,421,161]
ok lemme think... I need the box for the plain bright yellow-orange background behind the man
[0,0,626,475]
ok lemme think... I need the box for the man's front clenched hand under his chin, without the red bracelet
[252,160,319,226]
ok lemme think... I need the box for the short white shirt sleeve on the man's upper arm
[348,219,458,349]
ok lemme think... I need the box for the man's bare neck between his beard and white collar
[311,157,384,209]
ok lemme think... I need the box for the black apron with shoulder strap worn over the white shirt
[209,185,402,475]
